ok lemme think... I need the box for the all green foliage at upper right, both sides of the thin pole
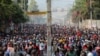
[71,0,100,20]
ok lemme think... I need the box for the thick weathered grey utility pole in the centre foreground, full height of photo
[47,0,52,56]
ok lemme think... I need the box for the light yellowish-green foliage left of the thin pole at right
[72,0,88,19]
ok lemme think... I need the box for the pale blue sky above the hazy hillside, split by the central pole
[35,0,74,10]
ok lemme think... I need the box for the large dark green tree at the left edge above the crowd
[0,0,28,32]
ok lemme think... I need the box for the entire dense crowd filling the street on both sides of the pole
[0,24,100,56]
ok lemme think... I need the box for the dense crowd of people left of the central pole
[0,24,46,56]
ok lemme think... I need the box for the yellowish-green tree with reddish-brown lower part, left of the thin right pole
[71,0,89,20]
